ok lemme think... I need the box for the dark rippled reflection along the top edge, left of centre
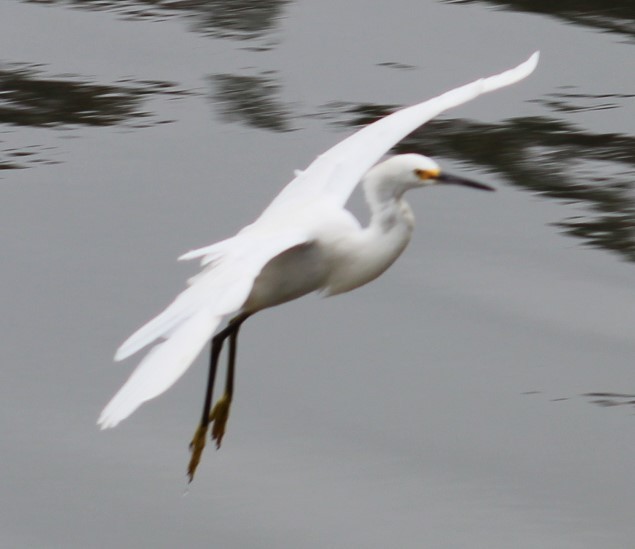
[26,0,289,39]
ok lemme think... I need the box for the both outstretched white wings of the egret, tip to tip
[98,52,538,428]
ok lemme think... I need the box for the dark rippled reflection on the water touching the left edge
[0,65,188,170]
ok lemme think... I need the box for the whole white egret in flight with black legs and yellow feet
[98,52,539,481]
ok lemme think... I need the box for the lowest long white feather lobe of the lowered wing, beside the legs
[97,310,222,429]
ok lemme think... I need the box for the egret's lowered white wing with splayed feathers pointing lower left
[97,232,306,429]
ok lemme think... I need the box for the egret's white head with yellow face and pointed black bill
[369,154,494,195]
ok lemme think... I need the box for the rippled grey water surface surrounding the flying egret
[0,0,635,549]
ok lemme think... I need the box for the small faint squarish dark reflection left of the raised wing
[210,73,291,132]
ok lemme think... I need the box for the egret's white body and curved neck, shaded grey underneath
[248,155,420,304]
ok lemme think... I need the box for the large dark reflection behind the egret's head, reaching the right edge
[328,102,635,261]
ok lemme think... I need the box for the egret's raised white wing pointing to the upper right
[261,52,539,217]
